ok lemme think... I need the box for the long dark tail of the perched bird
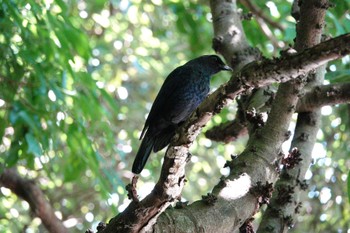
[132,133,154,174]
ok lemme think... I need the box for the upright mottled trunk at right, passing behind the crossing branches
[258,0,329,233]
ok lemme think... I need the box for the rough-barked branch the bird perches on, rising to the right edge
[103,34,350,232]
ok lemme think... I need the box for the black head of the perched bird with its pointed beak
[188,55,232,75]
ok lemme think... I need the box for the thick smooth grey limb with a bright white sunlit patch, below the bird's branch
[156,74,297,232]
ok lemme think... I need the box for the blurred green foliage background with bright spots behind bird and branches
[0,0,350,232]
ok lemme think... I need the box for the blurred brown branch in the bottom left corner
[0,169,68,233]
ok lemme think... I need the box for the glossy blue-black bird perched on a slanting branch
[132,55,232,174]
